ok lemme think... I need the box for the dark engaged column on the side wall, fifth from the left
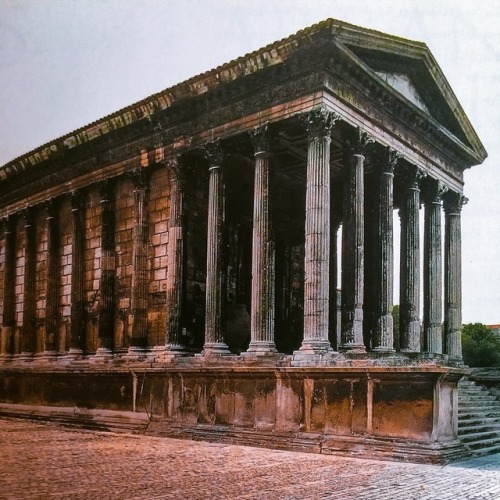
[97,181,116,355]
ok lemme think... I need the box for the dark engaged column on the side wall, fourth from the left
[69,191,85,355]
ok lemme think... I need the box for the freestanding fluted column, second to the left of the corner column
[203,142,231,356]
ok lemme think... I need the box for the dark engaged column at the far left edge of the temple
[0,216,17,357]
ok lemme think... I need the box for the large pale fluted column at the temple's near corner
[297,108,337,355]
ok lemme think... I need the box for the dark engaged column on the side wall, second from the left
[21,208,36,358]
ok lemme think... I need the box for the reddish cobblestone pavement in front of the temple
[0,419,500,500]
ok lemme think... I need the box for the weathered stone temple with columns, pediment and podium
[0,20,486,461]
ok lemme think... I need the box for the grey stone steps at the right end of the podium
[458,379,500,456]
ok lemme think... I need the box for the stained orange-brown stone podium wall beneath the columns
[0,363,464,461]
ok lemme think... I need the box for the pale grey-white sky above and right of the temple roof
[0,0,500,324]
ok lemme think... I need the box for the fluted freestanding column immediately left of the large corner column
[247,125,277,355]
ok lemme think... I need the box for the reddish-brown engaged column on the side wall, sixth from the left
[128,167,149,357]
